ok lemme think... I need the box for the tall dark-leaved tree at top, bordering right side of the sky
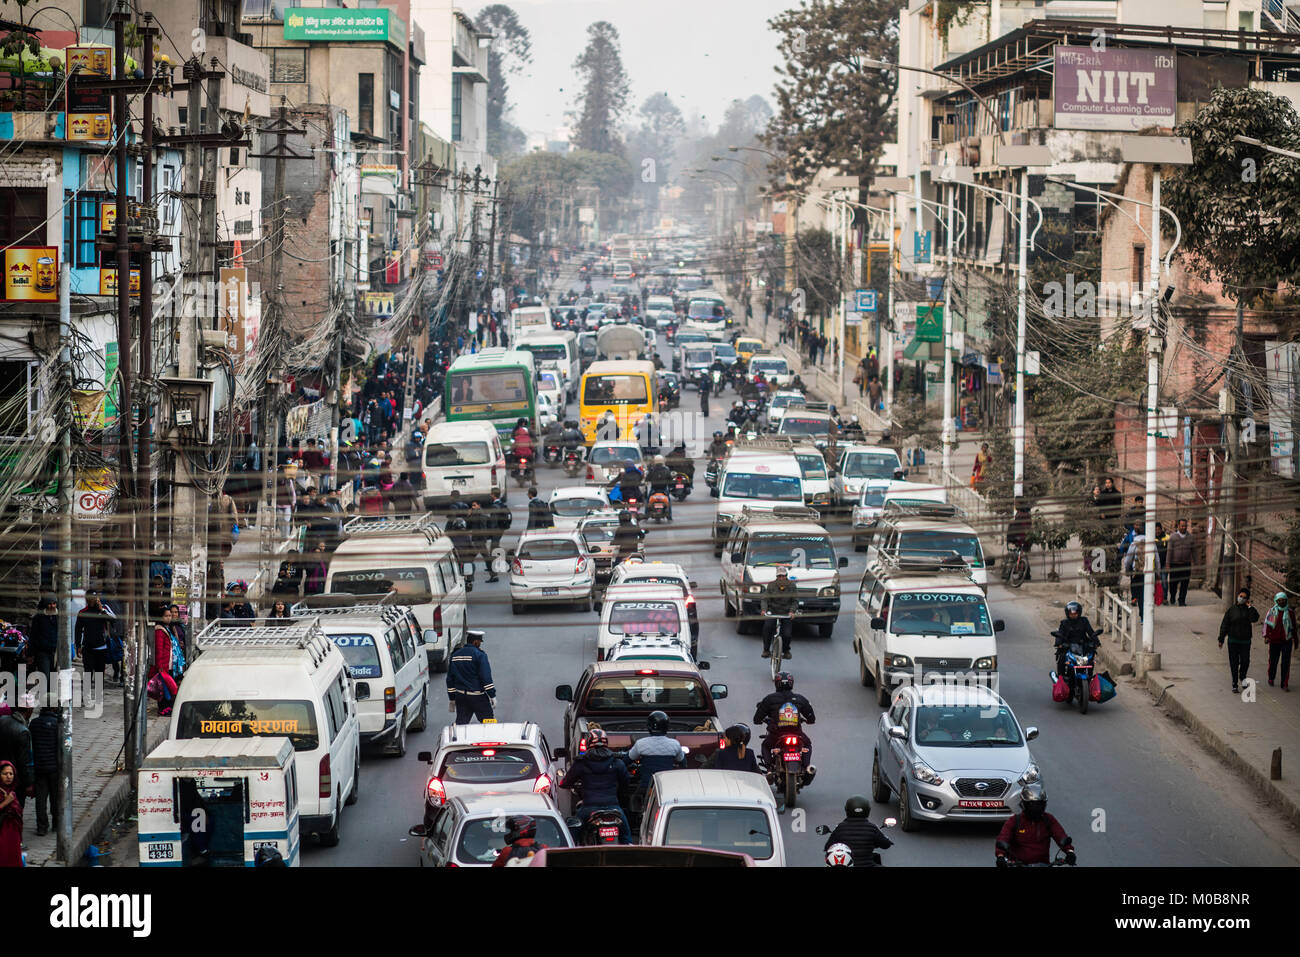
[763,0,902,192]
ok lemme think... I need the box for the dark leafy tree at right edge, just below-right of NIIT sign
[1161,87,1300,303]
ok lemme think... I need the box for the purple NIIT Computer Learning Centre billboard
[1053,46,1178,130]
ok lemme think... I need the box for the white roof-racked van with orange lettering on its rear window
[168,618,361,848]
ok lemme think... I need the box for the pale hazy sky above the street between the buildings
[483,0,797,137]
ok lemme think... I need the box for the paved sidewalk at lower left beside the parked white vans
[22,688,168,867]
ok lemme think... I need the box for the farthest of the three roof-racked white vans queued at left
[325,515,473,671]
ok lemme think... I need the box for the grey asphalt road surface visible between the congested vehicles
[303,274,1300,866]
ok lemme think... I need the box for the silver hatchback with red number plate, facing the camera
[871,684,1039,831]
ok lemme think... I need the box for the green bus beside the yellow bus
[442,348,538,449]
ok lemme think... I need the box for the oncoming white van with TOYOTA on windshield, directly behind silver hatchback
[853,560,1006,707]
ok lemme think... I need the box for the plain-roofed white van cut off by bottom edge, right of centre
[641,768,785,867]
